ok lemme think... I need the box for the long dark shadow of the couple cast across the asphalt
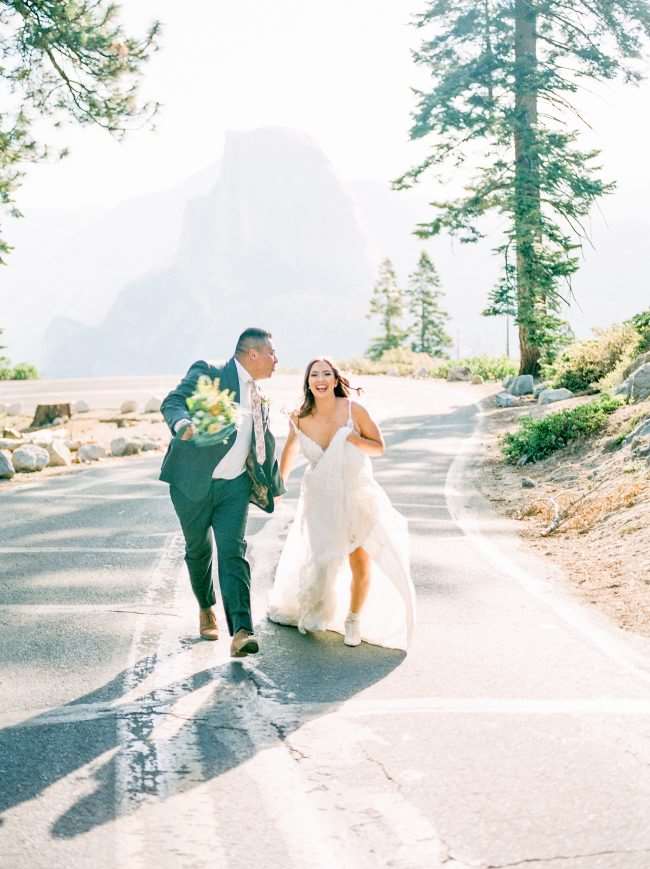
[0,623,405,838]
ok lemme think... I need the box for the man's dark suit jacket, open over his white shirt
[160,358,286,513]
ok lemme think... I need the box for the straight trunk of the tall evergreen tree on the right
[514,0,543,375]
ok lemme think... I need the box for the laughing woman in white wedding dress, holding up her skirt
[268,357,415,650]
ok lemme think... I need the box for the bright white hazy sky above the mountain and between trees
[20,0,650,215]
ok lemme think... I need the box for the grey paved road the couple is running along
[0,381,650,869]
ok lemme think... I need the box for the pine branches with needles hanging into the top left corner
[0,0,159,263]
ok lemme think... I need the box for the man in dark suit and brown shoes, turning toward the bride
[160,329,286,658]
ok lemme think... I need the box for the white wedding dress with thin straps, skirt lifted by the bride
[268,410,415,650]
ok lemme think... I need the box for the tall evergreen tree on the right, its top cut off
[395,0,650,374]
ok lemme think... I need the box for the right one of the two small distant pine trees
[406,251,453,356]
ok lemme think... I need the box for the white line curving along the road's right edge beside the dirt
[445,396,650,683]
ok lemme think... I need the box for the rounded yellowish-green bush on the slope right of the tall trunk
[543,323,639,392]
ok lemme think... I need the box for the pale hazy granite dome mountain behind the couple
[42,128,375,376]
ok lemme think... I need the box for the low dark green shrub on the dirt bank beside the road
[502,395,621,465]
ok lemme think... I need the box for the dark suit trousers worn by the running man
[169,472,253,636]
